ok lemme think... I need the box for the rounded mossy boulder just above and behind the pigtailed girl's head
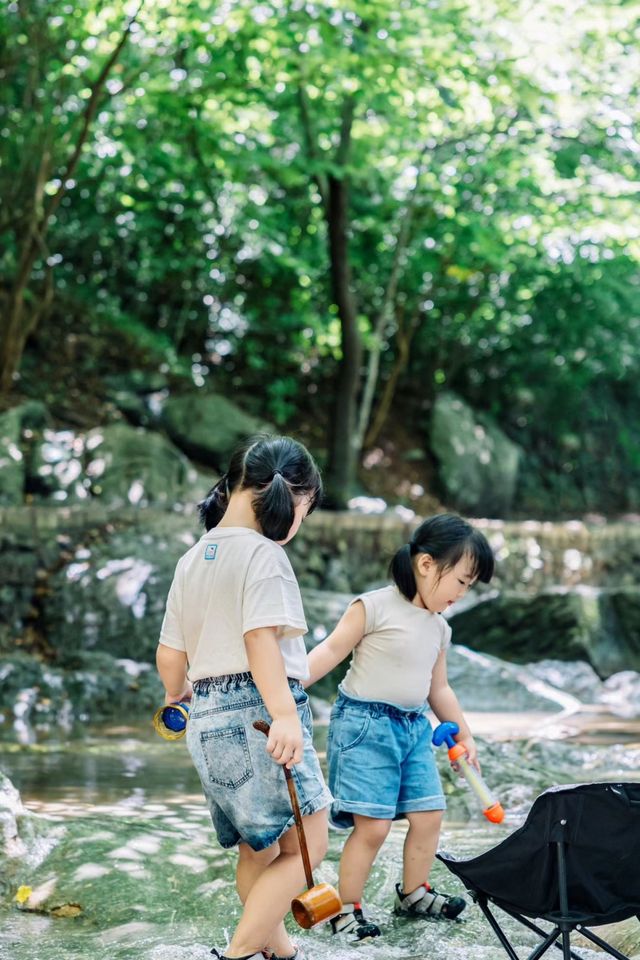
[162,393,275,470]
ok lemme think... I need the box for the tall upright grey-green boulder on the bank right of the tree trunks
[430,392,520,517]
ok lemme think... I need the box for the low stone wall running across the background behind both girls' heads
[0,501,640,594]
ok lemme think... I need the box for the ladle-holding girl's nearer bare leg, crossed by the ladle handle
[227,810,327,958]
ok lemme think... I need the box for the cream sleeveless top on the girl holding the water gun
[340,585,451,707]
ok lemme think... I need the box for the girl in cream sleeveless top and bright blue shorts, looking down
[305,514,494,940]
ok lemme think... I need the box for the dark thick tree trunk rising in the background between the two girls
[326,175,362,510]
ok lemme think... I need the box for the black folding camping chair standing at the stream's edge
[438,783,640,960]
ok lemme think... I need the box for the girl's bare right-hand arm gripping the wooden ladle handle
[244,627,303,769]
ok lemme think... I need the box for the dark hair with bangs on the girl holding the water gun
[389,513,495,600]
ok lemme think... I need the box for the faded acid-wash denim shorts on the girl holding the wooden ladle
[187,673,331,850]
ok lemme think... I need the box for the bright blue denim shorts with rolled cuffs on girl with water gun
[327,692,446,827]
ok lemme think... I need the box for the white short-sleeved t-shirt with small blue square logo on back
[160,527,309,681]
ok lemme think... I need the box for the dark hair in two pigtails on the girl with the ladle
[198,435,322,540]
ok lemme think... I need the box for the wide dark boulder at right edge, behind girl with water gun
[451,587,640,677]
